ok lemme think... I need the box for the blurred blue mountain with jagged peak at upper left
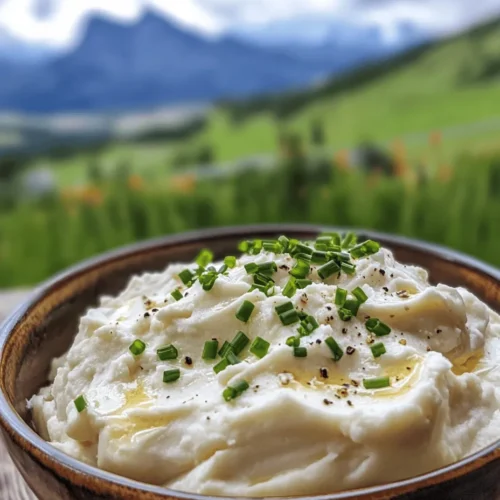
[0,12,334,112]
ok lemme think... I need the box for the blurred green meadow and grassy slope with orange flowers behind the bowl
[0,17,500,287]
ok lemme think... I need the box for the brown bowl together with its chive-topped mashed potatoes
[0,226,500,500]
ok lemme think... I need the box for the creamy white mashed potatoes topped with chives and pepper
[30,235,500,496]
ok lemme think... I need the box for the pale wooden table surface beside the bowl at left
[0,290,38,500]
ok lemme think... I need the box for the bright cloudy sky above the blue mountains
[0,0,500,48]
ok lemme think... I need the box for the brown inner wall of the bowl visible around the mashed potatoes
[2,226,500,424]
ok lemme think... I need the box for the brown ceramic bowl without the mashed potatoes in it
[0,226,500,500]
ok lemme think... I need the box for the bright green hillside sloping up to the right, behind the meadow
[194,16,500,160]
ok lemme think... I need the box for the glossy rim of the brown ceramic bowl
[0,224,500,500]
